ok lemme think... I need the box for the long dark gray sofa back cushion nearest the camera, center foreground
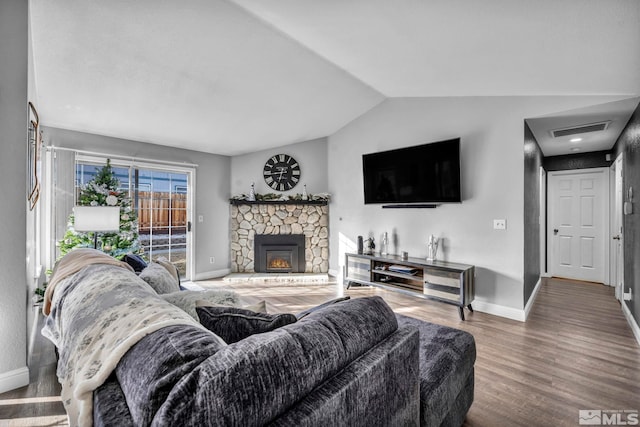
[154,297,398,426]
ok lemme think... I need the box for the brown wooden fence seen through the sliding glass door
[137,191,187,233]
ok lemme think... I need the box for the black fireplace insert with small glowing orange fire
[254,234,305,273]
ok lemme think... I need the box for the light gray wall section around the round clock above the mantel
[231,138,328,196]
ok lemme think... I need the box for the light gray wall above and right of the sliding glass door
[44,127,230,279]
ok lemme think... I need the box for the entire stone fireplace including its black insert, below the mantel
[230,201,329,273]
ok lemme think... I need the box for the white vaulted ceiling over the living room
[30,0,640,155]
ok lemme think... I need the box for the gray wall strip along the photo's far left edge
[0,0,29,393]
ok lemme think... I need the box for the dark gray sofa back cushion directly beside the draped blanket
[115,325,226,426]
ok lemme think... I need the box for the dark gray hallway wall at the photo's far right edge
[613,105,640,324]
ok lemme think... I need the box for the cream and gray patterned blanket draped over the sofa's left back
[42,264,211,427]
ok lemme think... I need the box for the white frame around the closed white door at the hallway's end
[547,167,611,285]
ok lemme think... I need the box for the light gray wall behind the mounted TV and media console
[328,97,620,318]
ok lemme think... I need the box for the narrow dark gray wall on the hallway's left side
[523,123,543,306]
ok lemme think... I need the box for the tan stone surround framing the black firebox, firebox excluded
[230,201,329,273]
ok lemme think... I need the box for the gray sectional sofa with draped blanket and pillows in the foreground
[42,249,476,427]
